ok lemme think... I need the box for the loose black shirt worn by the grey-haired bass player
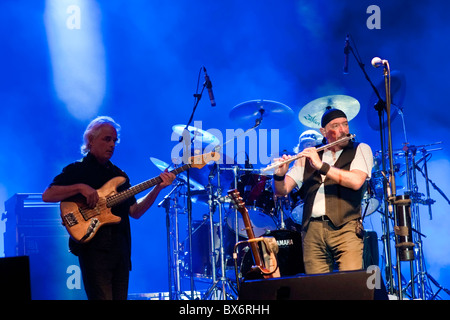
[50,153,136,257]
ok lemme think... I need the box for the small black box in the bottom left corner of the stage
[0,256,31,301]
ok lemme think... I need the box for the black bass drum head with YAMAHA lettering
[241,230,305,280]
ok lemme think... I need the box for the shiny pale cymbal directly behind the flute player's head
[298,95,360,128]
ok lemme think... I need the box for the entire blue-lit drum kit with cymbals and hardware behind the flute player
[151,74,446,300]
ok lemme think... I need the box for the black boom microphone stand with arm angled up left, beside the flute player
[348,35,394,294]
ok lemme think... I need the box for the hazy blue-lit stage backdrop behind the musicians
[0,0,450,293]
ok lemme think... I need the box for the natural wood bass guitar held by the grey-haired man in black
[60,152,220,243]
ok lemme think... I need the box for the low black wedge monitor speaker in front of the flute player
[239,270,388,300]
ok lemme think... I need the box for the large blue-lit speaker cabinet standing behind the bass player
[4,193,86,300]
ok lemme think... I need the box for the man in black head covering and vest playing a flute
[274,109,373,274]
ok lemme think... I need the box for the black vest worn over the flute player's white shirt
[299,142,364,230]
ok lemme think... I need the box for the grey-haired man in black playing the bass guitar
[42,116,175,300]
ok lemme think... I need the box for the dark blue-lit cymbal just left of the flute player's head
[229,99,294,128]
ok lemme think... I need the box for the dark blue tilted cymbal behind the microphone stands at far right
[367,70,406,130]
